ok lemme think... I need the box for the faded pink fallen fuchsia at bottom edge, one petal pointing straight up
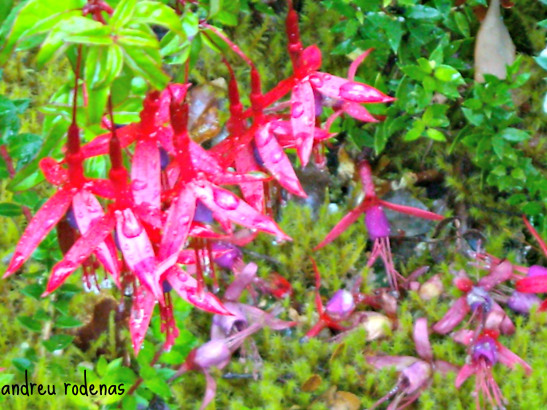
[367,318,458,410]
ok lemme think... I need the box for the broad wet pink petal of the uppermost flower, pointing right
[310,71,394,103]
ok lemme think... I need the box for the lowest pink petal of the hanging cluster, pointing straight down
[129,286,156,356]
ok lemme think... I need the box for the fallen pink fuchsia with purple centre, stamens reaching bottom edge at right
[455,330,532,409]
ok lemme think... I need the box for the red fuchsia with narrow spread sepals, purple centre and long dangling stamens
[314,161,444,290]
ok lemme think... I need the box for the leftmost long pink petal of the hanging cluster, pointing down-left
[4,187,74,278]
